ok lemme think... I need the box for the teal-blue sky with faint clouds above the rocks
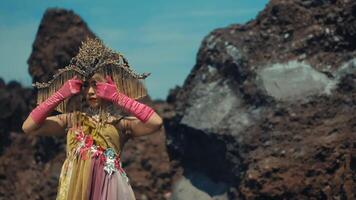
[0,0,267,99]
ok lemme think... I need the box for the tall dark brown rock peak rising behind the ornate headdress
[27,9,95,82]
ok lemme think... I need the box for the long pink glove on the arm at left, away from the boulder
[30,76,83,124]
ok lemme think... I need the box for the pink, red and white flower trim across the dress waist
[70,127,129,182]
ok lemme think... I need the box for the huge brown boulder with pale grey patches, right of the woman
[165,0,356,199]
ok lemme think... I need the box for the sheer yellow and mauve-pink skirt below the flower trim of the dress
[56,156,135,200]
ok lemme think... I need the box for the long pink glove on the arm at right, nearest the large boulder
[96,76,154,123]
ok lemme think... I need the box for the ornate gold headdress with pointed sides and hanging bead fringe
[32,38,150,122]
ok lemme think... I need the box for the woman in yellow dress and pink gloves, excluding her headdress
[22,38,162,200]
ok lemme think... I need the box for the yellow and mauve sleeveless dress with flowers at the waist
[56,113,135,200]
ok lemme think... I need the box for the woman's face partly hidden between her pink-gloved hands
[83,74,105,108]
